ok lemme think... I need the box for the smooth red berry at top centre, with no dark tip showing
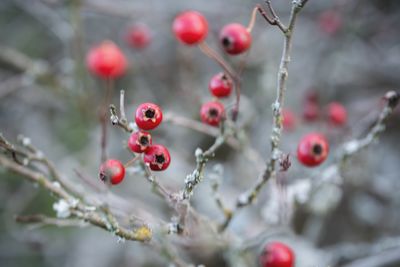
[172,11,208,45]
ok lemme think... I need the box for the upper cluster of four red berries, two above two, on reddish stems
[172,11,252,126]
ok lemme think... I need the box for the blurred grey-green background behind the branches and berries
[0,0,400,267]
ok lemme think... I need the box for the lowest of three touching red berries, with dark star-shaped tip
[143,145,171,171]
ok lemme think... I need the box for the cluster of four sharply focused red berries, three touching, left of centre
[100,103,171,185]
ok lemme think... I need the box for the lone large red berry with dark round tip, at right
[297,133,329,167]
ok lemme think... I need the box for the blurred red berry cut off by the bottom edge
[260,242,295,267]
